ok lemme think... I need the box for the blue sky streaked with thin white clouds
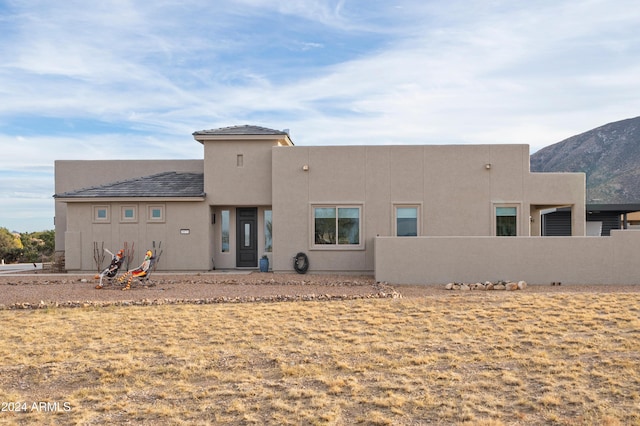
[0,0,640,231]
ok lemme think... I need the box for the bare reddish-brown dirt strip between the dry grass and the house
[0,272,640,309]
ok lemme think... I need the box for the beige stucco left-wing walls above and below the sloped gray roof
[55,160,206,271]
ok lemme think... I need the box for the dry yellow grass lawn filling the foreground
[0,291,640,425]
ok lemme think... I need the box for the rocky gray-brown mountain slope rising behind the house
[531,117,640,204]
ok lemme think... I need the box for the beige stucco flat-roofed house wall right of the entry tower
[272,145,585,273]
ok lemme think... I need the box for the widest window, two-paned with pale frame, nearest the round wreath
[313,207,361,247]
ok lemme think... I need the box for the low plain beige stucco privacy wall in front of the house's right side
[375,230,640,285]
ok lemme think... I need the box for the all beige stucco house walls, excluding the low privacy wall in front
[56,140,585,273]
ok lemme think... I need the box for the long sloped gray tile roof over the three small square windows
[54,172,205,198]
